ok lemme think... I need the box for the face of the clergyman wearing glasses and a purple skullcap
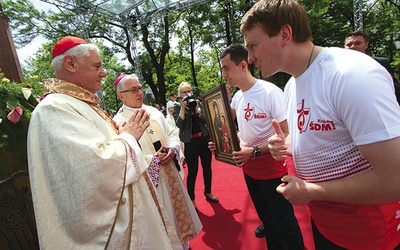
[119,79,144,108]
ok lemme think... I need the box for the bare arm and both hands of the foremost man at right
[269,117,400,205]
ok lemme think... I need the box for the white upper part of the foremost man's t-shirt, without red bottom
[285,48,400,182]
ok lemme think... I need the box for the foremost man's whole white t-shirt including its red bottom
[285,48,400,249]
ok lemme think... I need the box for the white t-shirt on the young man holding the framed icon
[231,79,286,147]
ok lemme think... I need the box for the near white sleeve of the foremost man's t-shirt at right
[331,65,400,145]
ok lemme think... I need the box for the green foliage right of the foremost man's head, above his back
[301,0,400,78]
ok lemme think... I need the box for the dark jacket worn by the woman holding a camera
[173,101,210,143]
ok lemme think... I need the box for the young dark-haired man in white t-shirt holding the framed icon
[212,44,304,249]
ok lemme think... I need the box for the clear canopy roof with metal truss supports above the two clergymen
[41,0,209,77]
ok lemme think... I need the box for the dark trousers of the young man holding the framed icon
[244,174,304,250]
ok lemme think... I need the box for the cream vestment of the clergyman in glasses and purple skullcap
[114,105,202,244]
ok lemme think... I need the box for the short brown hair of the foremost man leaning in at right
[240,0,312,43]
